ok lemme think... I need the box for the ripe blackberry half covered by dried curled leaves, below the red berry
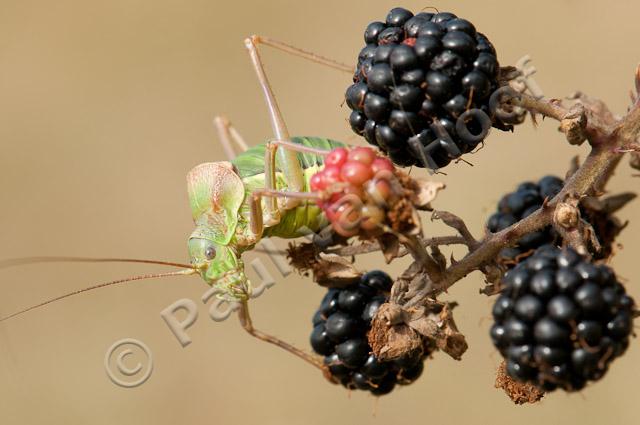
[310,270,427,396]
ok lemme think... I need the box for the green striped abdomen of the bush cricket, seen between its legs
[231,137,345,238]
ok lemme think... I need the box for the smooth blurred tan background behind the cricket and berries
[0,0,640,425]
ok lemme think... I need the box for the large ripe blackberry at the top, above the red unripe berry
[346,8,512,169]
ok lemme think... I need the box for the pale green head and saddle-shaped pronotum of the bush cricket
[187,162,249,300]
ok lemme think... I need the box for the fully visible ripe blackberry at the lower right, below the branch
[490,246,634,391]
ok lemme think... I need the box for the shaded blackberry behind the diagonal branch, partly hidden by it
[487,176,621,266]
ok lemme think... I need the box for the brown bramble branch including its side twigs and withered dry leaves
[288,67,640,374]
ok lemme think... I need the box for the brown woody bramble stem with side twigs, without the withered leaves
[308,67,640,308]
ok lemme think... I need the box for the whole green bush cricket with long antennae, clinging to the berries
[0,36,353,369]
